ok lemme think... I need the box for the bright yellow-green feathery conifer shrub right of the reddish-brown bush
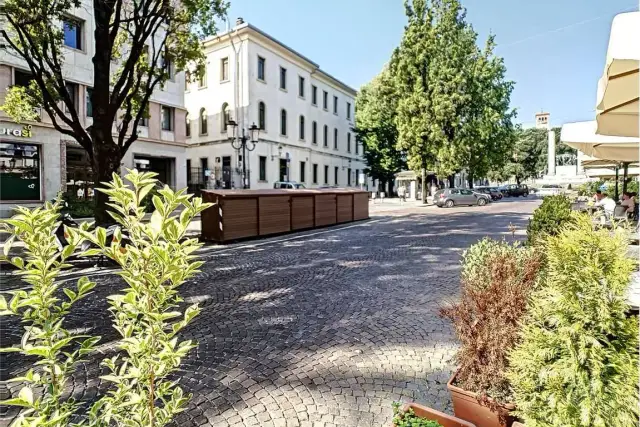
[508,217,639,427]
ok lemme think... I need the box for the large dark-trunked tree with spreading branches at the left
[0,0,228,223]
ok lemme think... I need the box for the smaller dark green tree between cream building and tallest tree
[355,67,406,194]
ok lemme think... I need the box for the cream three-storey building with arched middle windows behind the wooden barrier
[185,19,368,189]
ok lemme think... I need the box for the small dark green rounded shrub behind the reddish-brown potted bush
[527,195,574,245]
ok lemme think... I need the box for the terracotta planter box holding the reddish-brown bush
[447,371,515,427]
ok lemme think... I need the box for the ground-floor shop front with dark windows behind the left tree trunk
[0,121,187,218]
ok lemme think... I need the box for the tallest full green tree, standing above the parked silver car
[391,0,515,192]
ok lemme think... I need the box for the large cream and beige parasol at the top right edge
[596,12,640,137]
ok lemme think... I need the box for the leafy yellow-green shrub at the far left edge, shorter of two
[0,201,99,427]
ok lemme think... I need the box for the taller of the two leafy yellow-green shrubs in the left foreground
[81,170,209,426]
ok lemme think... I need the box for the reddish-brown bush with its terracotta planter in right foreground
[441,239,542,427]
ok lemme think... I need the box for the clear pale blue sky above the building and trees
[222,0,638,126]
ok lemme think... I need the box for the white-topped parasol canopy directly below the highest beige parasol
[560,121,640,162]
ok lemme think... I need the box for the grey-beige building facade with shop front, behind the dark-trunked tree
[0,0,187,217]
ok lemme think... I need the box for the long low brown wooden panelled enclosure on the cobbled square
[201,189,369,243]
